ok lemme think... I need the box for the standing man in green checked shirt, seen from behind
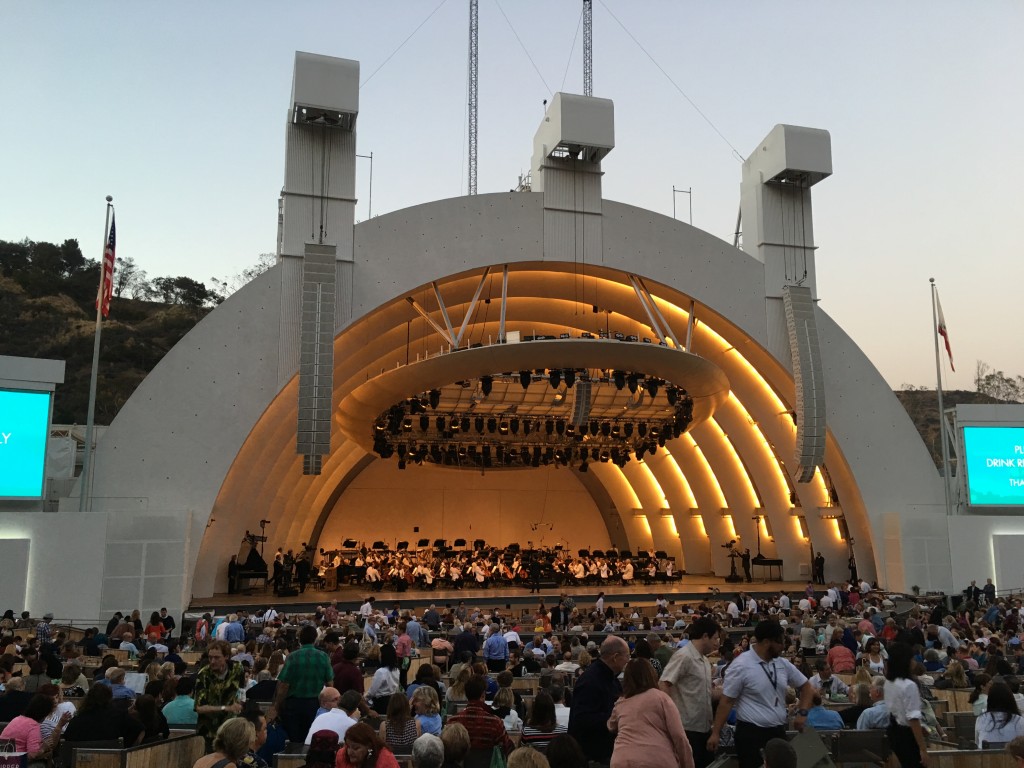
[266,625,334,741]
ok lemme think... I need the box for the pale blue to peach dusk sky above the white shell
[0,0,1024,389]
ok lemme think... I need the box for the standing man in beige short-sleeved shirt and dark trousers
[659,616,722,768]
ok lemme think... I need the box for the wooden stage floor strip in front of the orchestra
[188,575,807,613]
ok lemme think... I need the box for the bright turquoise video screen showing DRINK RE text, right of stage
[964,427,1024,507]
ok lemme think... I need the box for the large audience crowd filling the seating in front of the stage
[6,585,1024,768]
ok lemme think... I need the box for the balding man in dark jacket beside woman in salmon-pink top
[568,635,630,765]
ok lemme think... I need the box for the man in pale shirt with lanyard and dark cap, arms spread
[708,620,814,768]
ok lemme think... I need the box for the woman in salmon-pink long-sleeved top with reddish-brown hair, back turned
[608,658,693,768]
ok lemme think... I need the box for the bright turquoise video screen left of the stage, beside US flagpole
[0,389,51,499]
